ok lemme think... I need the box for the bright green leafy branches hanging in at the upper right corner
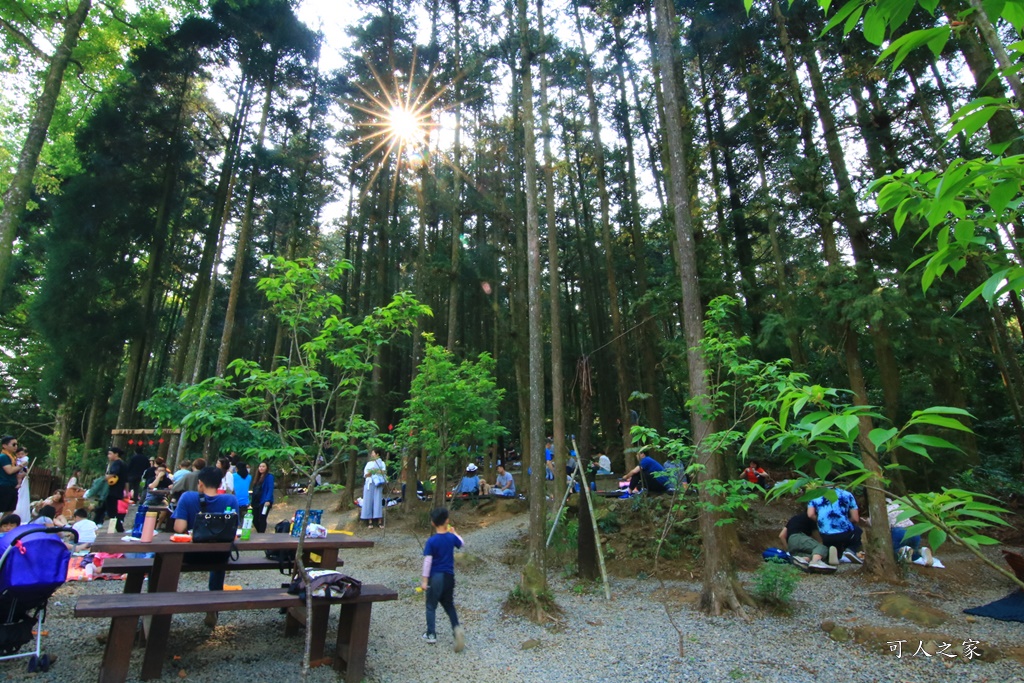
[818,0,1024,307]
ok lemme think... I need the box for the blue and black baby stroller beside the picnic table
[0,524,78,673]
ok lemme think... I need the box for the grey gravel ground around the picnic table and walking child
[9,515,1024,683]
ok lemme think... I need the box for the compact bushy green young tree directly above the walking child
[395,335,507,481]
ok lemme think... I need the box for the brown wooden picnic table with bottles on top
[83,533,374,680]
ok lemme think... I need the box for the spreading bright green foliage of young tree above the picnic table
[140,258,430,478]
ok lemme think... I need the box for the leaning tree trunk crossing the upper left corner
[0,0,92,298]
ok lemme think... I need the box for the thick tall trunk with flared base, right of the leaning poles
[654,0,753,614]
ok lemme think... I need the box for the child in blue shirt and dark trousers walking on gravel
[420,508,466,652]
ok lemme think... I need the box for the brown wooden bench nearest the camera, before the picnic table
[75,584,398,683]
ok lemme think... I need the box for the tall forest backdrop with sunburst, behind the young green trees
[0,0,1024,532]
